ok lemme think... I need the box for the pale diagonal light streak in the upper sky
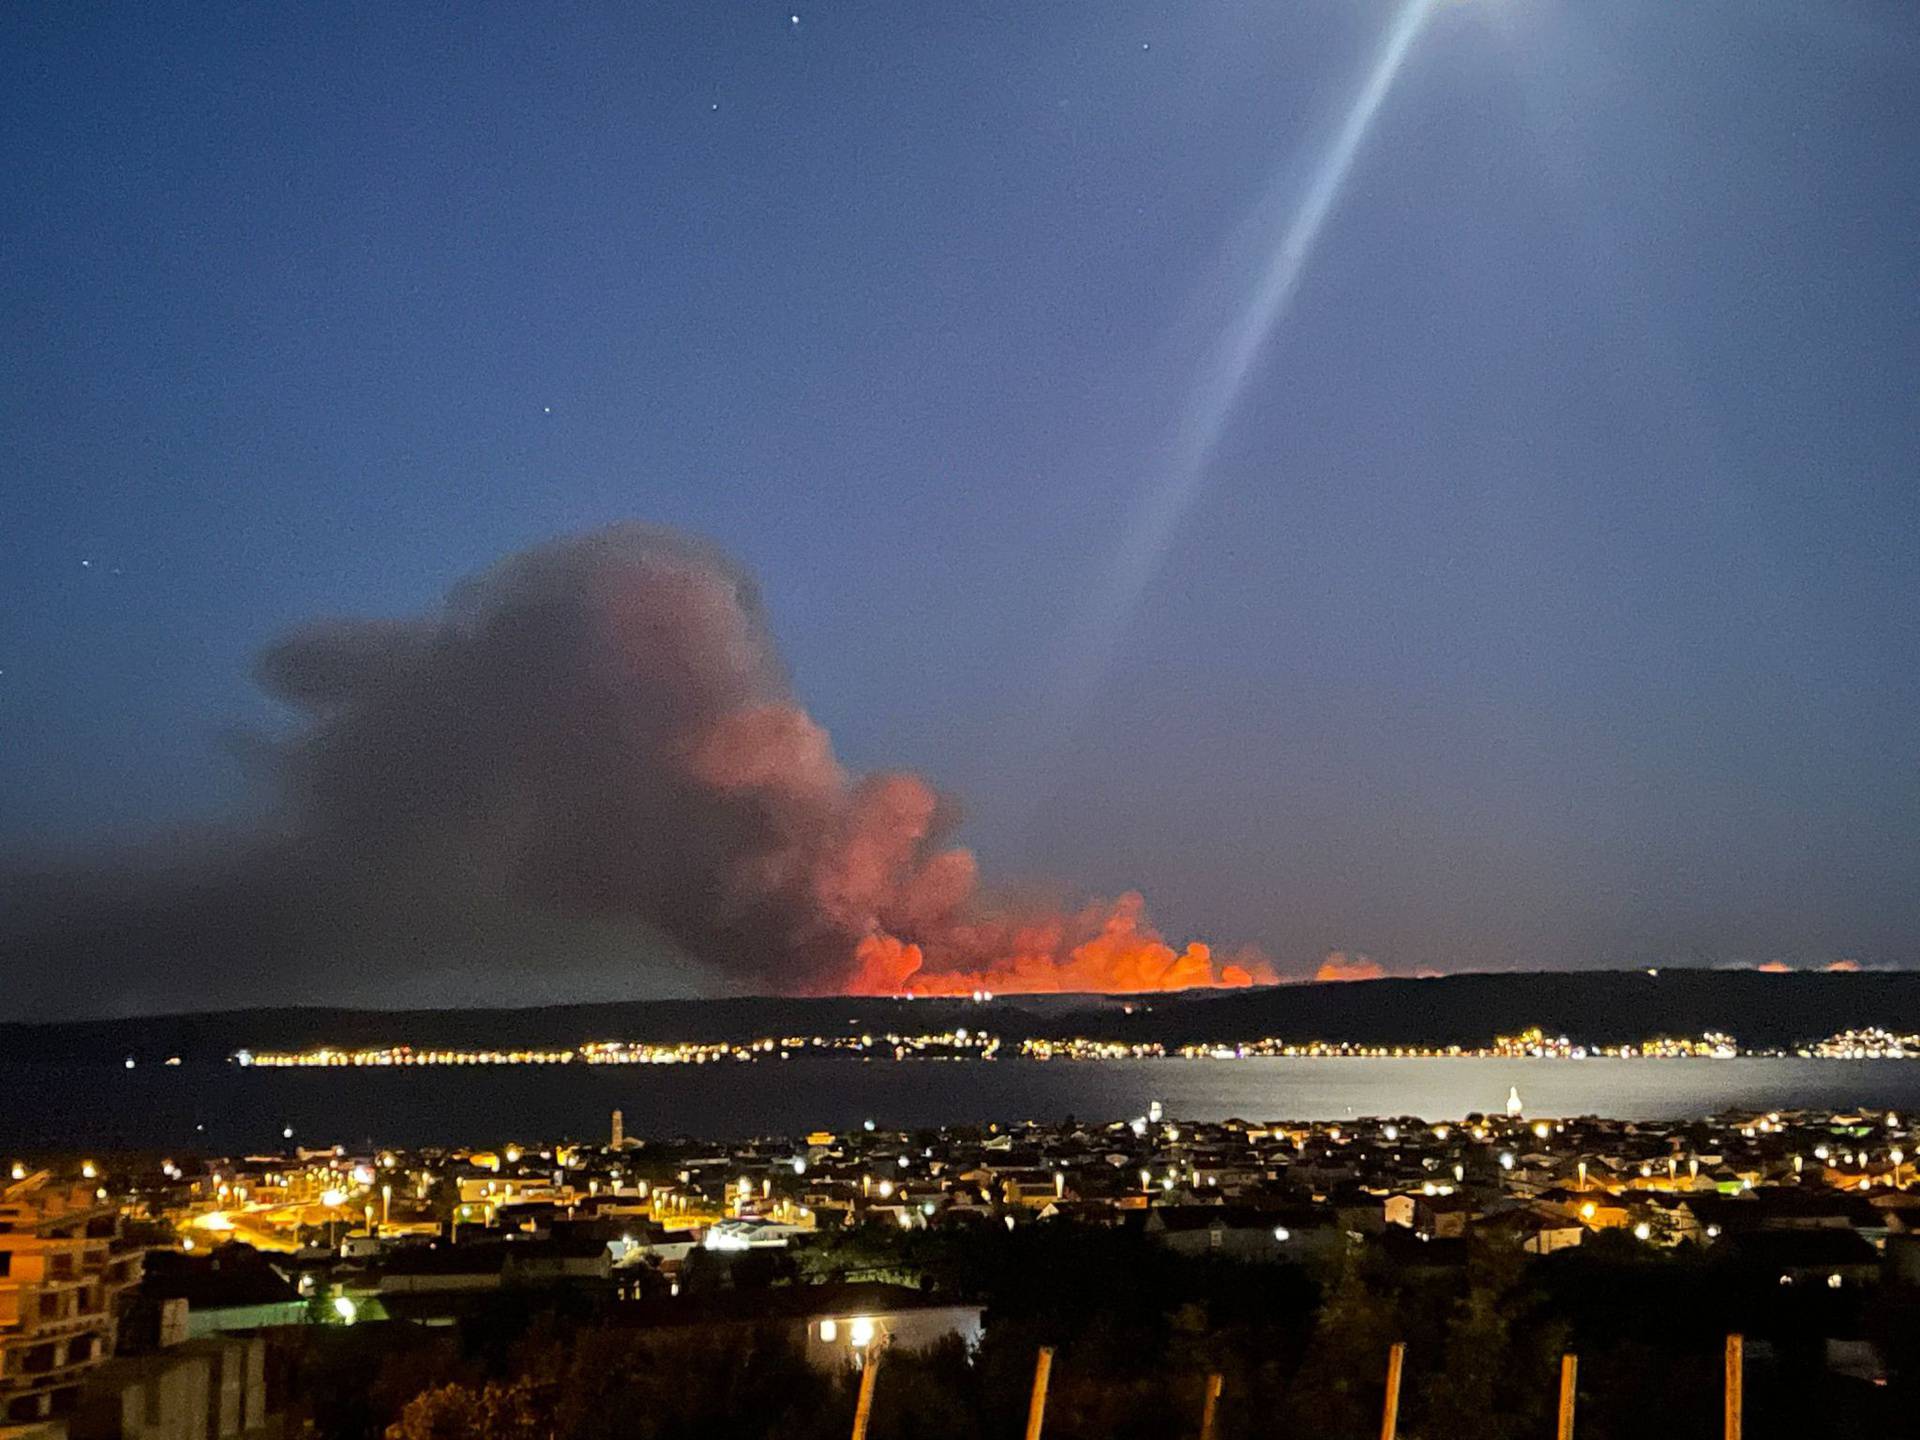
[1066,0,1436,724]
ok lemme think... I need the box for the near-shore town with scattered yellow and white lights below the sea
[0,1092,1920,1440]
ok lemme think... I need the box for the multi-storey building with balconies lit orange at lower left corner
[0,1173,140,1425]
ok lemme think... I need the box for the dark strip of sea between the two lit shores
[11,1058,1920,1160]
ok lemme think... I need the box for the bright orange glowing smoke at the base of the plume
[847,893,1279,995]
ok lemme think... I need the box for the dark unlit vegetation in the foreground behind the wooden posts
[278,1225,1914,1440]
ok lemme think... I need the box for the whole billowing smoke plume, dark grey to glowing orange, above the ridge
[0,524,1273,993]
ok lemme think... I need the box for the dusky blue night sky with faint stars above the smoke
[0,0,1920,989]
